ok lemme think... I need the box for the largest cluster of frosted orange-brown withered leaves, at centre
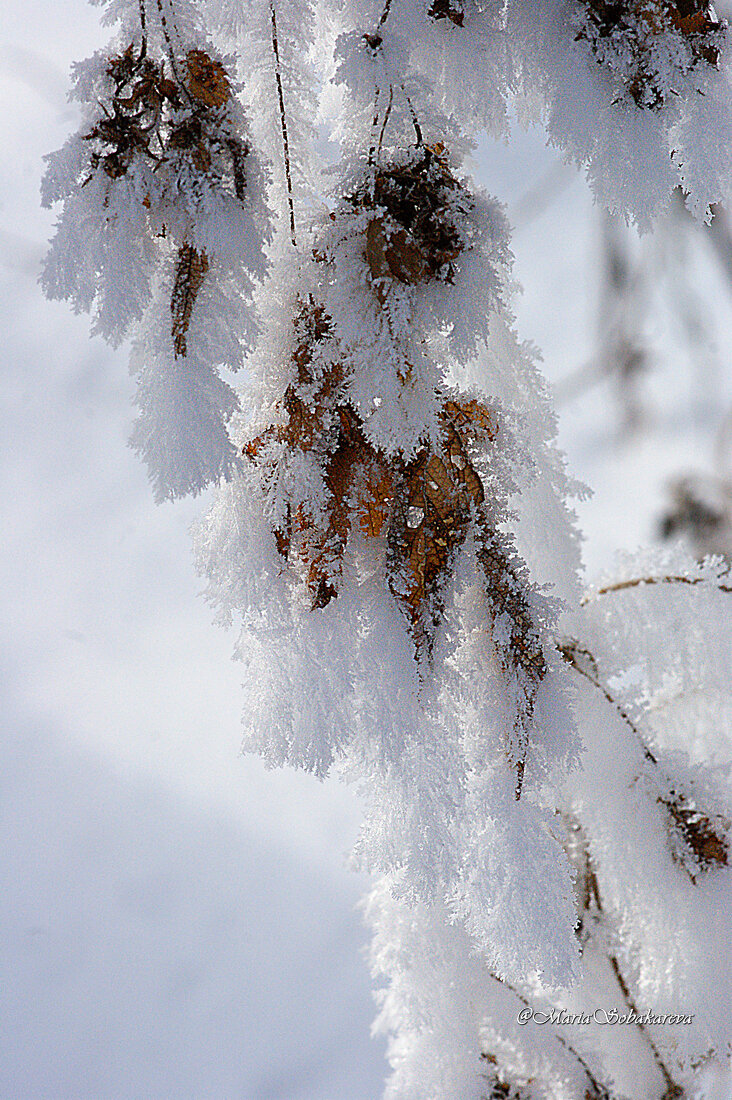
[244,303,547,798]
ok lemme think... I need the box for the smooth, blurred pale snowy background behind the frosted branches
[0,0,732,1100]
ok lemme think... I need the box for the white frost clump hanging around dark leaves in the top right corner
[506,0,732,229]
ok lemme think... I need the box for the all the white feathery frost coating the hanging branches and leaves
[37,0,732,1100]
